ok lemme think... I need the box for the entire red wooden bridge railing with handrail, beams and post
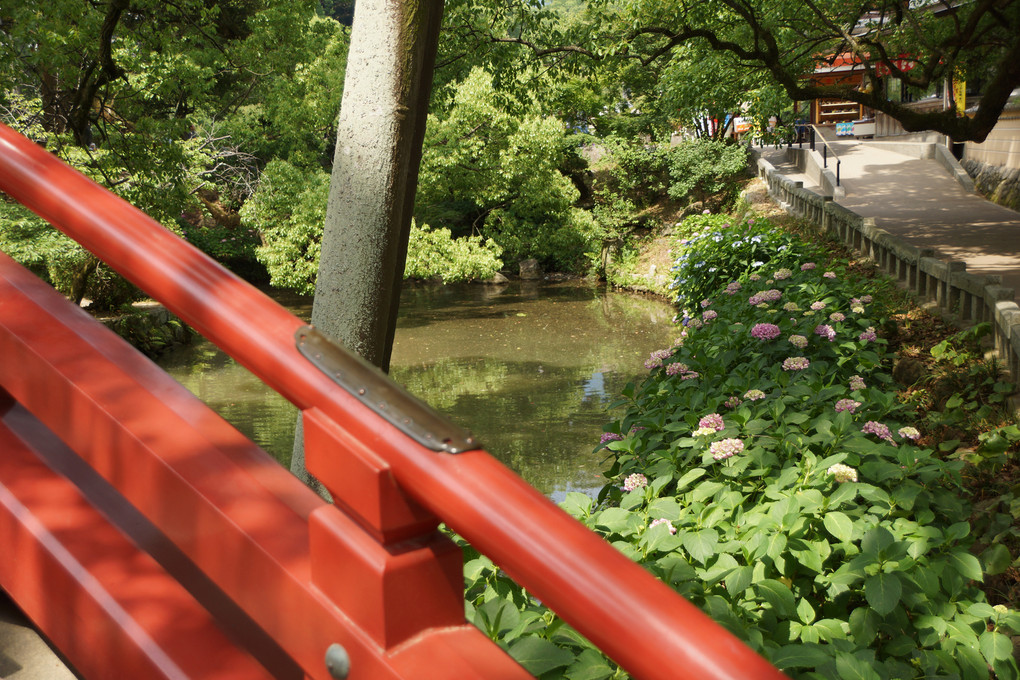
[0,126,784,680]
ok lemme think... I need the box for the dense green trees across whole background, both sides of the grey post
[0,0,1020,305]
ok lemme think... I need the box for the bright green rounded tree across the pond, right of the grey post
[415,69,593,270]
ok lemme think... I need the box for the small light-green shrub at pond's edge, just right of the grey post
[404,222,503,283]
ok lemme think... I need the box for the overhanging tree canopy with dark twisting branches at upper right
[465,0,1020,141]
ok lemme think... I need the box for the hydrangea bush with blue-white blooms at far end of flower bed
[670,214,816,311]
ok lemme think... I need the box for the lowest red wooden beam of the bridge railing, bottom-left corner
[0,409,272,680]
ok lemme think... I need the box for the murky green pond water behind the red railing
[159,281,675,499]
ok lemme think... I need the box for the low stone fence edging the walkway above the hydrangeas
[758,152,1020,379]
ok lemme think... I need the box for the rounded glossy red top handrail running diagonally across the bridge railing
[0,125,785,680]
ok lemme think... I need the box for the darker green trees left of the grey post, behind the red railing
[0,0,348,297]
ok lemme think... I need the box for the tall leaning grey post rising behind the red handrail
[291,0,443,491]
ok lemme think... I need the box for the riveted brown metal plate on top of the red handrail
[295,326,481,454]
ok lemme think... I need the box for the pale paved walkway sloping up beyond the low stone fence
[762,141,1020,298]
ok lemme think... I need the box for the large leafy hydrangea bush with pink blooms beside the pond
[467,235,1020,680]
